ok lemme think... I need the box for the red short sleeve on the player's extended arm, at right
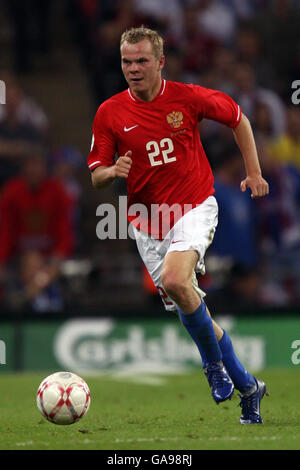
[193,85,242,128]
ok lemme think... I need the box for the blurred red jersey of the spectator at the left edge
[0,177,74,265]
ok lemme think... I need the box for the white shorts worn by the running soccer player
[132,196,218,310]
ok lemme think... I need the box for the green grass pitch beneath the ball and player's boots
[0,367,300,450]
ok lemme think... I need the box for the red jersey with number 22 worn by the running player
[88,80,241,238]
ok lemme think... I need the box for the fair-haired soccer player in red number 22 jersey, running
[88,27,268,424]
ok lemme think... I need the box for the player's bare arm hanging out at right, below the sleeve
[233,114,269,198]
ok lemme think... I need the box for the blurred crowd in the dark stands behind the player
[0,0,300,374]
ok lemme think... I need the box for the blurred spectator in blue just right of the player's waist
[211,145,258,267]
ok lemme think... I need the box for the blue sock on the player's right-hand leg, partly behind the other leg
[219,330,256,392]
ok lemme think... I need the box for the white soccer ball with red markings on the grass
[36,372,91,424]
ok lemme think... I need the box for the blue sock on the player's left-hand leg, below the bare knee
[178,301,222,367]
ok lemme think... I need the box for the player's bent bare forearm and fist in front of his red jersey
[91,150,132,189]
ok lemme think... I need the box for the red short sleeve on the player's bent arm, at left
[87,103,116,171]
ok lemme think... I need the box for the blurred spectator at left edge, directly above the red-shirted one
[0,73,48,186]
